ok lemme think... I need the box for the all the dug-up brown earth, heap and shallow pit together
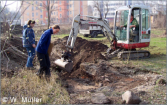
[51,37,161,104]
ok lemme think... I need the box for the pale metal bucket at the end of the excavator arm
[54,59,73,72]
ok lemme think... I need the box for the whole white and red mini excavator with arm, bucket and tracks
[54,5,151,72]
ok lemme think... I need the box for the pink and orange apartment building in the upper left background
[21,0,88,25]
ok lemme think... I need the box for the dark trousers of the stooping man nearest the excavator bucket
[37,52,51,76]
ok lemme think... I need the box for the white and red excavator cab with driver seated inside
[114,5,151,49]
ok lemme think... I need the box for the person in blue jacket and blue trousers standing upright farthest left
[23,20,36,69]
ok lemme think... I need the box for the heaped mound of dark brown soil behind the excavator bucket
[50,37,108,76]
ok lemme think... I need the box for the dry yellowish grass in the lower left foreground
[1,69,69,104]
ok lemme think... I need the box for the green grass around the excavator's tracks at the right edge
[111,38,166,76]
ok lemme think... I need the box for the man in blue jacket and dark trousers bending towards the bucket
[36,25,60,81]
